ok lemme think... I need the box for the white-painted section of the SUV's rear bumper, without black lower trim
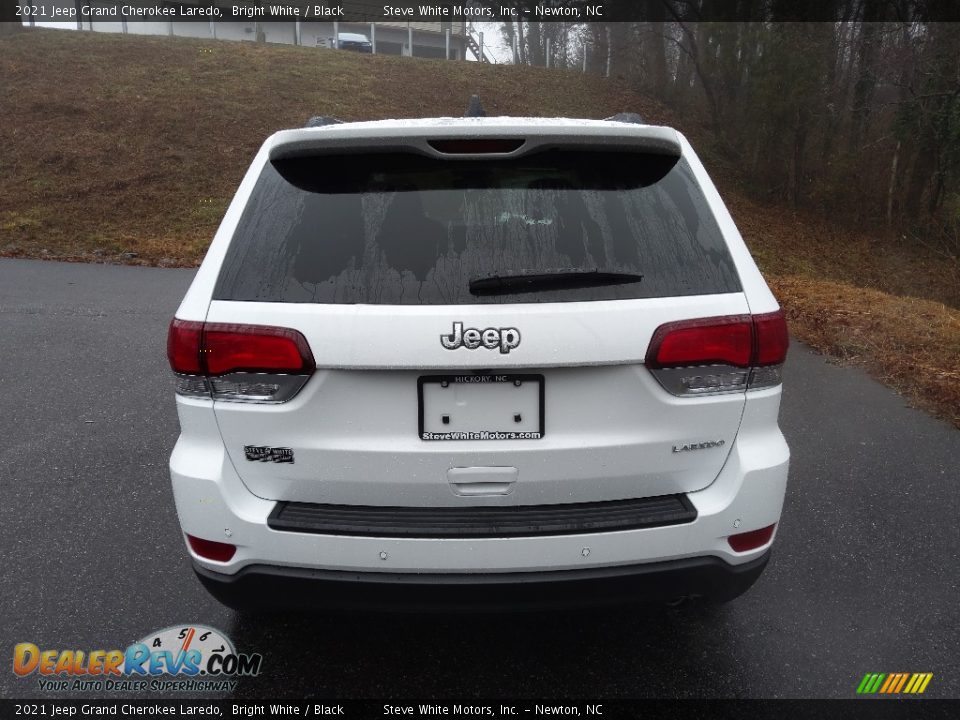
[170,390,789,576]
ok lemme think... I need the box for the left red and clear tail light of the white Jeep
[167,318,316,402]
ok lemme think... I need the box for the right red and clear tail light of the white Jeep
[646,310,790,396]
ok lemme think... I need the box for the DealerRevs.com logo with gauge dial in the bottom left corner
[13,624,263,692]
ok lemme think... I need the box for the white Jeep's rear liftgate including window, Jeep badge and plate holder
[207,125,749,506]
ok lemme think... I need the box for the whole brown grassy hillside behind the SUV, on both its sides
[0,30,960,427]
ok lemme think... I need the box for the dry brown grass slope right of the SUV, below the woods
[725,183,960,428]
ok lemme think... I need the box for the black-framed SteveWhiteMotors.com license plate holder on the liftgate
[417,373,545,441]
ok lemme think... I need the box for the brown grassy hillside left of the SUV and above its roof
[0,30,676,265]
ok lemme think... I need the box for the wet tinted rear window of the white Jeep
[214,150,741,305]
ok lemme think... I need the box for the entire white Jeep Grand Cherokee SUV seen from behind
[168,116,789,610]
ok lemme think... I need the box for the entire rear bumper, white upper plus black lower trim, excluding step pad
[170,389,789,610]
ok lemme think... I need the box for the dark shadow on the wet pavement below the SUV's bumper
[230,607,748,699]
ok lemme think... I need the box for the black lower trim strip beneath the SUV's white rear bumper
[194,550,770,612]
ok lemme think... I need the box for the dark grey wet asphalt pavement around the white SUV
[0,259,960,698]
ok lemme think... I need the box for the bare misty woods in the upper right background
[502,5,960,262]
